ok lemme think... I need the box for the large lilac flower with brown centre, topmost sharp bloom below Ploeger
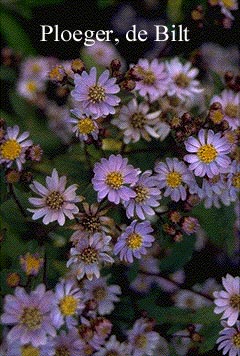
[71,67,120,117]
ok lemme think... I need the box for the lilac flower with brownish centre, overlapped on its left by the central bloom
[124,171,161,220]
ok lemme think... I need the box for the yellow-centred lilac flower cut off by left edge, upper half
[0,125,32,171]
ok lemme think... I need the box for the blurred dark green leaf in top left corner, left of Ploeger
[0,11,36,55]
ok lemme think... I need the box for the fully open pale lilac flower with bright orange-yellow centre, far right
[184,129,231,178]
